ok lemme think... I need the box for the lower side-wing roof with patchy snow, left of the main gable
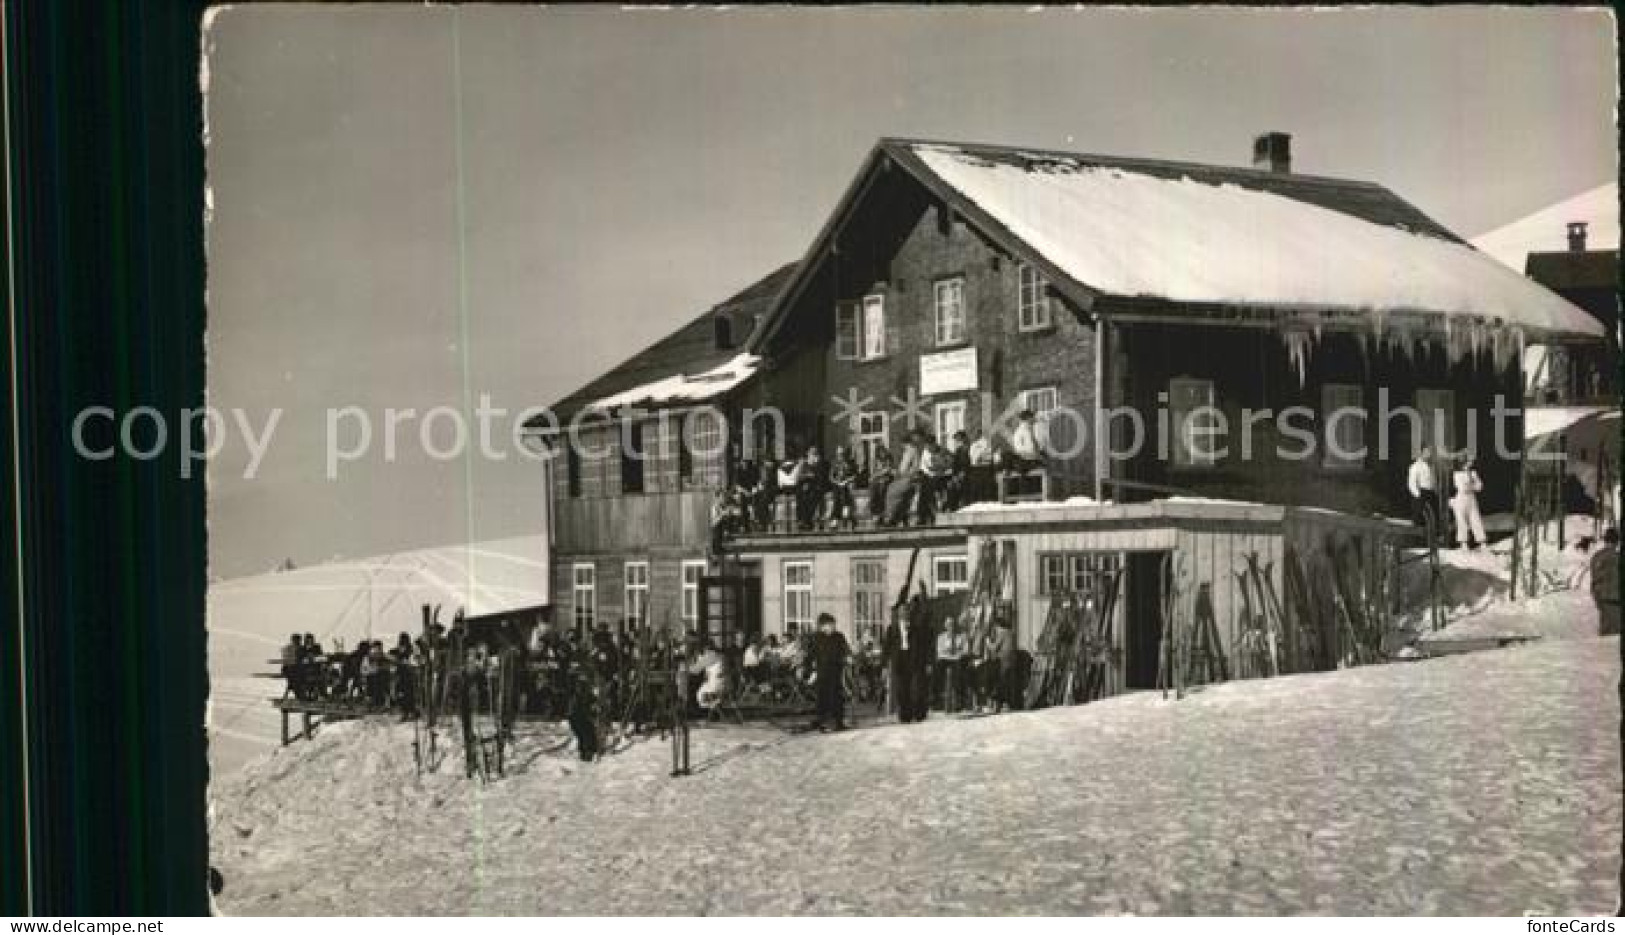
[539,263,793,428]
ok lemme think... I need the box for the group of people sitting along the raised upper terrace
[712,410,1045,550]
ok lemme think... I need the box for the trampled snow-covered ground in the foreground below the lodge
[213,637,1622,914]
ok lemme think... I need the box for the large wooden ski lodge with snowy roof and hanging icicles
[529,133,1602,686]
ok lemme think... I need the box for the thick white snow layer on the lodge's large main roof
[912,143,1602,335]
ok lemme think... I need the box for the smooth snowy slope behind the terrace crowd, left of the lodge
[206,535,548,772]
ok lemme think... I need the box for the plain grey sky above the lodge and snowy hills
[203,5,1619,577]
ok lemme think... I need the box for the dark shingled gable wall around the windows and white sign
[746,172,1095,489]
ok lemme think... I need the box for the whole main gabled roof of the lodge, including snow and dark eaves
[752,140,1599,350]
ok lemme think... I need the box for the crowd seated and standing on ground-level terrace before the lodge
[271,602,1024,759]
